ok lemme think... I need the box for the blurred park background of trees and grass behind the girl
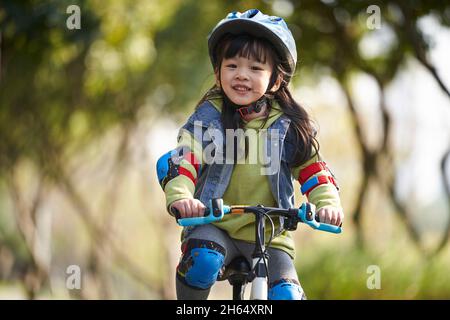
[0,0,450,299]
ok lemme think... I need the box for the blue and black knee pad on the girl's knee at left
[177,239,225,289]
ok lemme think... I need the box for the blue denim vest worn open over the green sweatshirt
[182,101,295,209]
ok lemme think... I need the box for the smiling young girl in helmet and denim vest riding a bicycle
[158,9,344,300]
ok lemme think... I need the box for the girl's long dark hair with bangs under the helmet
[197,33,319,167]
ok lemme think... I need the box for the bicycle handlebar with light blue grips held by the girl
[172,199,342,233]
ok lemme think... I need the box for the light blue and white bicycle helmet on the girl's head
[208,9,297,79]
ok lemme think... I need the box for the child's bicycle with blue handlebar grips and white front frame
[174,199,342,300]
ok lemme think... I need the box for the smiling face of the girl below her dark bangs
[216,55,278,106]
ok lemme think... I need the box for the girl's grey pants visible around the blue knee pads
[176,224,298,300]
